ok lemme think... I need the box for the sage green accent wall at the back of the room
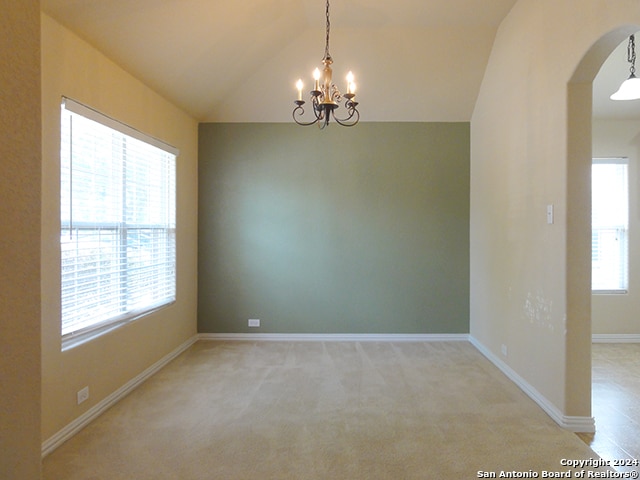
[198,123,470,334]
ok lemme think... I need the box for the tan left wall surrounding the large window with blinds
[42,14,198,440]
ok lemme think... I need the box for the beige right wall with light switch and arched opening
[470,0,640,426]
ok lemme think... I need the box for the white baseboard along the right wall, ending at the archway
[469,335,596,433]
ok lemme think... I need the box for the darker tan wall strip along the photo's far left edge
[0,0,41,479]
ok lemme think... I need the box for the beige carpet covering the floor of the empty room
[43,341,602,480]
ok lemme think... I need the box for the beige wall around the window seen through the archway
[591,120,640,334]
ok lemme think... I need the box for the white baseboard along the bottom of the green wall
[198,333,469,342]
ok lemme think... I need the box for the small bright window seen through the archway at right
[591,158,629,293]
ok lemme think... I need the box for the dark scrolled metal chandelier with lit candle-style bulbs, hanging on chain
[293,0,360,128]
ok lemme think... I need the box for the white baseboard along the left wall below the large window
[42,335,198,458]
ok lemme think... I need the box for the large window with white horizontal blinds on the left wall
[60,98,177,348]
